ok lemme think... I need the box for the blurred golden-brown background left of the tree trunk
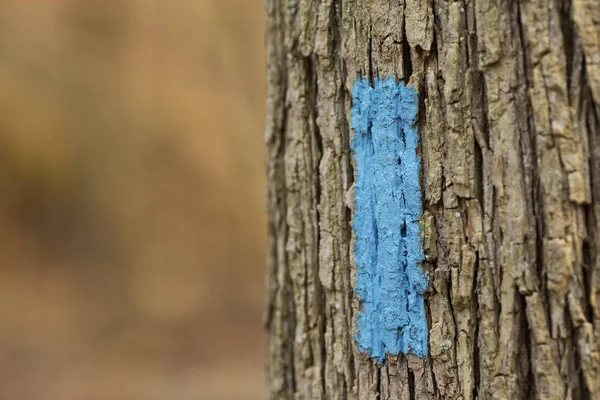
[0,0,266,400]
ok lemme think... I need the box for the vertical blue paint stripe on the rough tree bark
[352,77,428,361]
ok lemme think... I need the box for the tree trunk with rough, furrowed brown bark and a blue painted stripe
[266,0,600,399]
